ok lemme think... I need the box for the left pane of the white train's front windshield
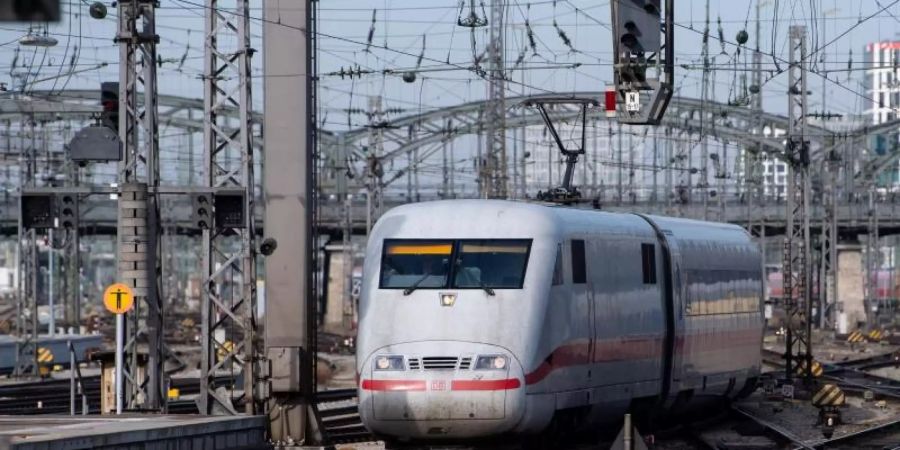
[381,240,453,289]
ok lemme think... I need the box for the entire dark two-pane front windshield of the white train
[379,239,531,290]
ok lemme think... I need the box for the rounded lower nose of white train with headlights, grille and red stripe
[359,341,525,439]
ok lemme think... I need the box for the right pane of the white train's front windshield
[452,243,531,289]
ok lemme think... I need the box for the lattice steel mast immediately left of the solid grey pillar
[199,0,261,414]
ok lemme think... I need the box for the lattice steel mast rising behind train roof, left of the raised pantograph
[478,0,509,198]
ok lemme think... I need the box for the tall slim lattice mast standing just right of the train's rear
[782,25,812,381]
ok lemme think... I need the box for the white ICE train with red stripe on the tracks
[357,200,764,440]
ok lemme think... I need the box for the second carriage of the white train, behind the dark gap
[649,216,764,395]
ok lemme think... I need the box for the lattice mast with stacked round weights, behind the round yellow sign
[116,0,165,410]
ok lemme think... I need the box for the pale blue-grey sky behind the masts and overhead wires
[0,0,900,128]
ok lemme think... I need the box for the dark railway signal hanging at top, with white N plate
[610,0,675,125]
